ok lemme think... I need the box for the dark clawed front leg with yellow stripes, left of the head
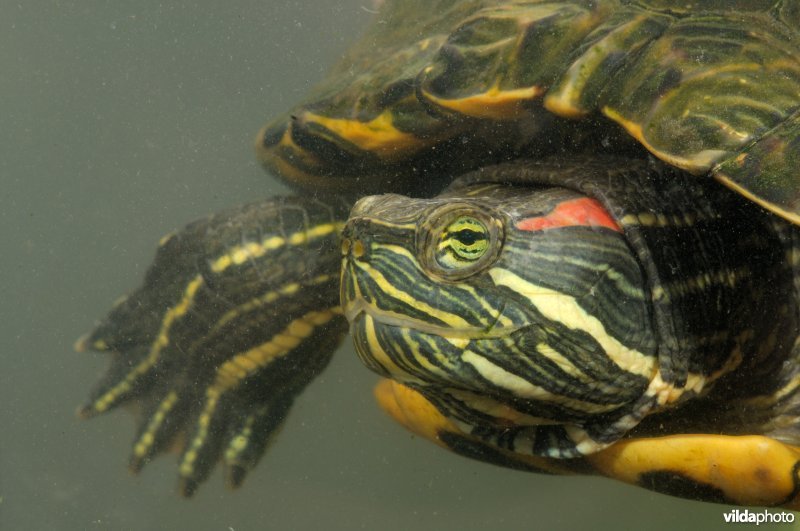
[76,197,348,496]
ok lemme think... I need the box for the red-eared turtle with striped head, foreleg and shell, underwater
[76,0,800,509]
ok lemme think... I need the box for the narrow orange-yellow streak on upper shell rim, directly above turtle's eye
[422,85,544,120]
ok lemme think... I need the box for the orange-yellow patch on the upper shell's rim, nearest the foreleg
[302,109,429,160]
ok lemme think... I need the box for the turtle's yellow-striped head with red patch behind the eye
[341,185,657,457]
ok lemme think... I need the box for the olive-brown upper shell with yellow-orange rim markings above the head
[257,0,800,223]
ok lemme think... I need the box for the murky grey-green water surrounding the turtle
[0,0,789,531]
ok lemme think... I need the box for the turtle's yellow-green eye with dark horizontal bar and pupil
[436,216,490,269]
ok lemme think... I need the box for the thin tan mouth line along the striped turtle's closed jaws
[344,297,520,339]
